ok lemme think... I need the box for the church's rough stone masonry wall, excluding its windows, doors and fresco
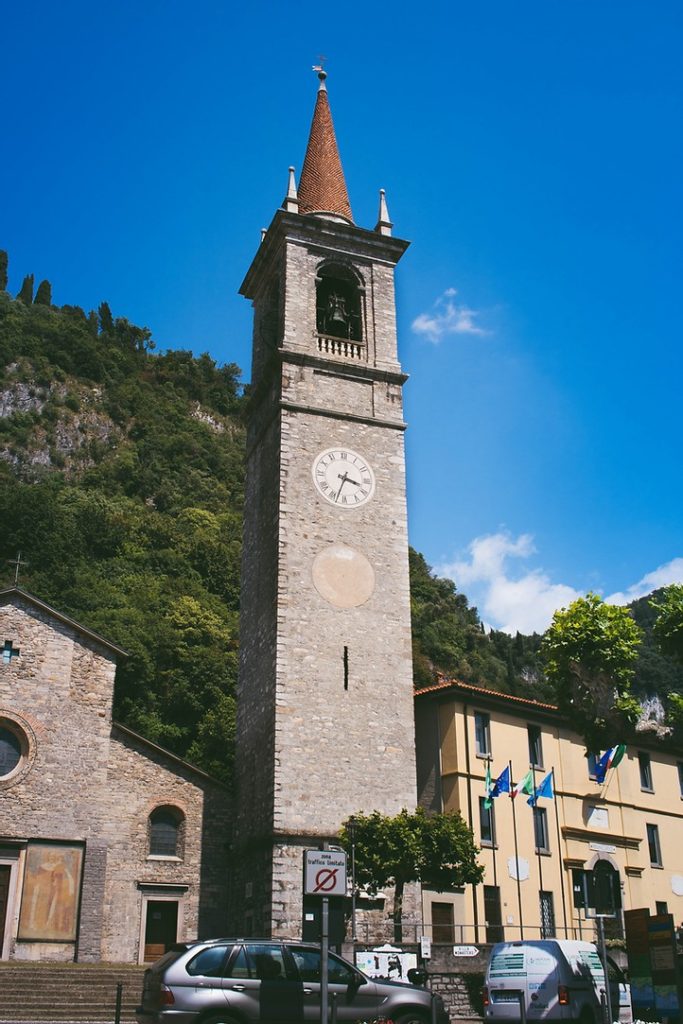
[0,593,231,961]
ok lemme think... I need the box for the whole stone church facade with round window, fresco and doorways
[0,588,231,963]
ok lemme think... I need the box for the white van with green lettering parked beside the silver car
[483,939,633,1024]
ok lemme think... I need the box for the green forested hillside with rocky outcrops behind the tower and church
[0,253,683,779]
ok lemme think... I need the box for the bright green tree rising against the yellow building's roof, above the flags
[541,594,642,752]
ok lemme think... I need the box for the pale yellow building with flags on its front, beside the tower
[416,681,683,944]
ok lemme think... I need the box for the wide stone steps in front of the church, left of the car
[0,961,144,1024]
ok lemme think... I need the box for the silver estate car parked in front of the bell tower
[135,939,449,1024]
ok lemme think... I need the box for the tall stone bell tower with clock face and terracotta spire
[231,72,416,936]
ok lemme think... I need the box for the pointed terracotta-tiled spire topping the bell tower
[299,71,353,223]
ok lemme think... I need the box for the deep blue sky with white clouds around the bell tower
[0,0,683,631]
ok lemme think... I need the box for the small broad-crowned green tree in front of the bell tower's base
[340,807,483,942]
